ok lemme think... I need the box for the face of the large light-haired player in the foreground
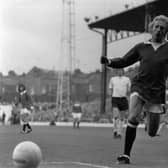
[152,20,166,43]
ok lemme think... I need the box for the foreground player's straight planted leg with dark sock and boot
[117,93,144,164]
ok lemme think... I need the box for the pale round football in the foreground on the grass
[12,141,42,168]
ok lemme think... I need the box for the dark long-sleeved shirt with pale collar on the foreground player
[108,43,168,104]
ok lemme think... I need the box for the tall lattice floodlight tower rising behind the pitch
[56,0,76,112]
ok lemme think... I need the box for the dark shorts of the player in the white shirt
[111,97,128,111]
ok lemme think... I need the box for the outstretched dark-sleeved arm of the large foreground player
[100,45,140,68]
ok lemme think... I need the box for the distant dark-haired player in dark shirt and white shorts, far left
[16,84,32,133]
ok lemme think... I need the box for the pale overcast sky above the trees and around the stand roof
[0,0,147,74]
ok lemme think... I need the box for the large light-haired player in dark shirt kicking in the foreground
[101,15,168,164]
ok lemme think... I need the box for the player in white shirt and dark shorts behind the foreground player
[109,69,131,138]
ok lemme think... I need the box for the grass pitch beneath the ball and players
[0,126,168,168]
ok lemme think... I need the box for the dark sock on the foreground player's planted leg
[124,125,136,156]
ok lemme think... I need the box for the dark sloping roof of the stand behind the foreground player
[88,0,168,32]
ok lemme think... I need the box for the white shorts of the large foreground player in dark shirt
[130,92,164,114]
